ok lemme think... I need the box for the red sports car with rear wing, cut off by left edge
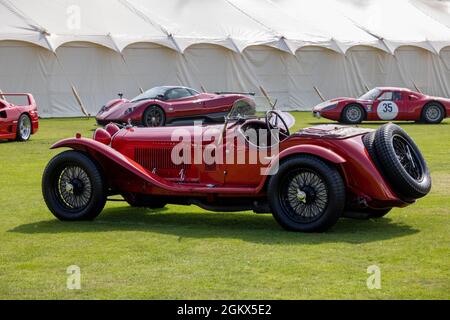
[0,93,39,141]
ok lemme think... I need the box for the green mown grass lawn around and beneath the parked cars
[0,113,450,299]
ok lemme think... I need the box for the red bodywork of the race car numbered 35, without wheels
[313,87,450,121]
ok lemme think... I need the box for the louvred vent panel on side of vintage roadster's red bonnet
[134,147,189,171]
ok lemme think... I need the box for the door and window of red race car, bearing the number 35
[373,90,405,121]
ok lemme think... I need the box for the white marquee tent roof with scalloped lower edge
[0,0,450,53]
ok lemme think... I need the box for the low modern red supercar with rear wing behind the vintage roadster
[96,86,251,127]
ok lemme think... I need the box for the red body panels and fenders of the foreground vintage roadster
[52,119,408,210]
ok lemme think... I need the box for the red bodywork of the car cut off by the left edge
[0,93,39,140]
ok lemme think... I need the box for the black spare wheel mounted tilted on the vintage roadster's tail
[373,123,431,201]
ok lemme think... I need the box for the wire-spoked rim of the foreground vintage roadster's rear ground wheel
[279,169,328,223]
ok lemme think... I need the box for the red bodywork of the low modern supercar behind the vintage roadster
[96,89,245,125]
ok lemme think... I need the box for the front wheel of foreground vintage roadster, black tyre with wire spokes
[42,150,107,221]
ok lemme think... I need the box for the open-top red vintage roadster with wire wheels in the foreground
[42,99,431,232]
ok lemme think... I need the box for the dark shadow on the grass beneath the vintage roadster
[9,207,419,244]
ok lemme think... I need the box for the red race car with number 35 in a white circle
[313,87,450,124]
